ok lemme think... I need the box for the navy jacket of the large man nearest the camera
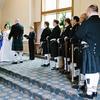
[76,15,100,55]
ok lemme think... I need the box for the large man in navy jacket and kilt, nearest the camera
[77,5,100,99]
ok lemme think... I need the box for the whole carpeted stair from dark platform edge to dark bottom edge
[0,68,78,100]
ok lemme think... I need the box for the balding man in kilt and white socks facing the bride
[8,19,24,64]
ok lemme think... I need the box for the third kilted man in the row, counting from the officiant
[59,18,72,73]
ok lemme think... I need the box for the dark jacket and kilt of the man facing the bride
[8,23,24,51]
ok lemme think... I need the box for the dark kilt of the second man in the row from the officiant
[50,41,58,57]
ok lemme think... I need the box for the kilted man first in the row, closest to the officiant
[40,21,51,67]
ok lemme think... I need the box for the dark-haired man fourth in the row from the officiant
[70,16,80,83]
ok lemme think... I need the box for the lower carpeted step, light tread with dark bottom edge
[0,74,69,100]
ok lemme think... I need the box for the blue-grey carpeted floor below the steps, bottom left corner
[0,81,35,100]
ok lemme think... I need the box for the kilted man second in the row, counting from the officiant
[49,20,61,70]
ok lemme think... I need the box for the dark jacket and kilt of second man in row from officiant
[49,26,61,57]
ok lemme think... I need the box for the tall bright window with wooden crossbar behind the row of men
[42,0,72,28]
